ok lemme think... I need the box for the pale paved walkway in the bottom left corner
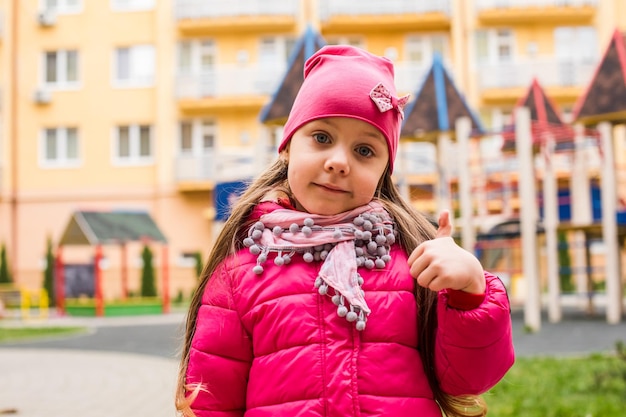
[0,348,178,417]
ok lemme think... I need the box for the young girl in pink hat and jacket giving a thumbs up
[176,46,514,417]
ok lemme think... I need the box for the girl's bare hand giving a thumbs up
[408,210,485,294]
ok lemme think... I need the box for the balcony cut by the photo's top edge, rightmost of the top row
[476,0,598,26]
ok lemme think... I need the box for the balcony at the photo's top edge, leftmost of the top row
[174,0,299,36]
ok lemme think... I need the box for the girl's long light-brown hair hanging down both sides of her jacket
[176,158,487,417]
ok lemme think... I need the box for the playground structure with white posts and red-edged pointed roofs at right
[405,31,626,330]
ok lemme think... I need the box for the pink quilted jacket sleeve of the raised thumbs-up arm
[435,272,515,395]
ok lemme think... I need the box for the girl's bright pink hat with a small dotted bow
[278,45,409,171]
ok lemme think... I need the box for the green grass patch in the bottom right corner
[484,346,626,417]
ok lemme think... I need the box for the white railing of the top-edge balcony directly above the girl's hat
[320,0,450,20]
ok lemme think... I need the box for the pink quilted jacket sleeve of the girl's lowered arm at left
[187,267,252,417]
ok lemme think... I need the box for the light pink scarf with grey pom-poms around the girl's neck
[243,201,396,330]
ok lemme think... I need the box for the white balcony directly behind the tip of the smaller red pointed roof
[477,57,597,104]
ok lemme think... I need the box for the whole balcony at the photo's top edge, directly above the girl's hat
[319,0,451,34]
